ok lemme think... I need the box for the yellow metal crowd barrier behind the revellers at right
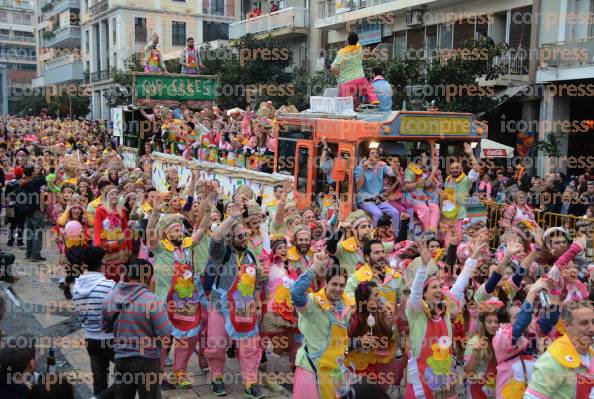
[482,201,594,259]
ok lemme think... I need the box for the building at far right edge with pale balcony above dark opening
[535,0,594,174]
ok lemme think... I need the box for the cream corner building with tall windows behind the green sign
[80,0,239,119]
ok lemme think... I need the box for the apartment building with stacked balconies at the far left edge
[0,0,37,114]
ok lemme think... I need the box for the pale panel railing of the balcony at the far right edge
[539,37,594,68]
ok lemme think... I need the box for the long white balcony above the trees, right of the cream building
[229,7,309,40]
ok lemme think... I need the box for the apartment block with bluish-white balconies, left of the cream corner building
[33,0,83,92]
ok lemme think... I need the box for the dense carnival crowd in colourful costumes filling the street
[0,110,594,399]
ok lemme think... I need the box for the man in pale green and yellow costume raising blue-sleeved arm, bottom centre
[291,252,354,399]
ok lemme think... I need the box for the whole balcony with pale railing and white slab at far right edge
[536,37,594,83]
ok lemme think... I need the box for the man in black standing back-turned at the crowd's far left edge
[17,166,45,262]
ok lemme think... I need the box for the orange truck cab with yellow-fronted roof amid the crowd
[274,111,488,218]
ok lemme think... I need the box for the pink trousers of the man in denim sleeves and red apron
[204,309,262,386]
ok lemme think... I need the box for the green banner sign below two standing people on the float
[134,73,216,103]
